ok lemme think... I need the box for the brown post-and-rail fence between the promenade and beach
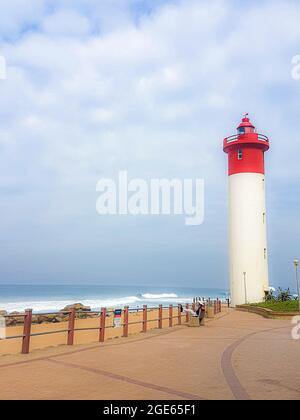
[0,298,222,354]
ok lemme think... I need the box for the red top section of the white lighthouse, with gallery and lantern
[223,114,270,175]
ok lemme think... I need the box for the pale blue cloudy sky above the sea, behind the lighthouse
[0,0,300,289]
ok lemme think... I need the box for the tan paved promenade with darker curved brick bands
[0,310,300,400]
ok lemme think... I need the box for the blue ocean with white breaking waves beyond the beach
[0,284,228,313]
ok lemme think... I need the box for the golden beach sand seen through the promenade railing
[0,307,186,356]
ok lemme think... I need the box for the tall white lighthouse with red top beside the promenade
[223,114,269,307]
